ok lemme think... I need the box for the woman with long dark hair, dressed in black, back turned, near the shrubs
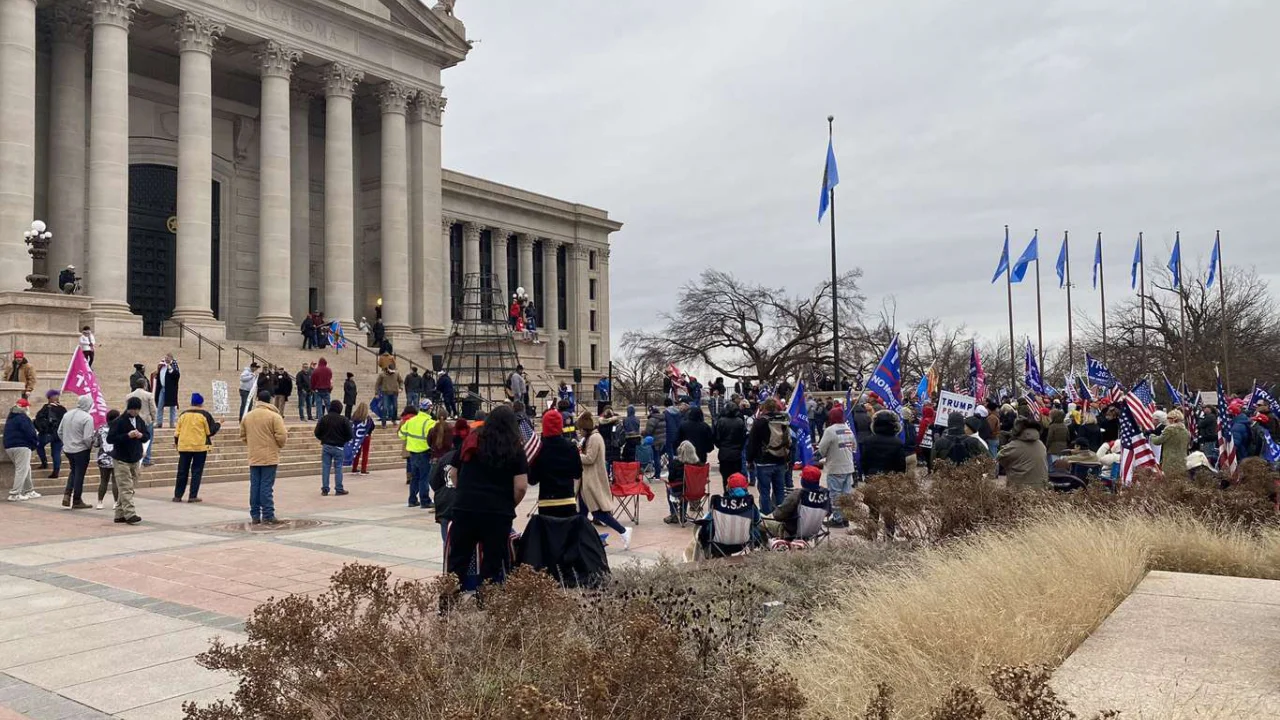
[444,405,529,583]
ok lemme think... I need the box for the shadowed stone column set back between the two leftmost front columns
[46,4,88,280]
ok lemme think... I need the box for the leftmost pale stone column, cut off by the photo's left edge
[0,0,35,291]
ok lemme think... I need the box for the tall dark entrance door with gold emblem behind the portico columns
[128,165,220,336]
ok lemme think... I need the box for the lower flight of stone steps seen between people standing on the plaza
[33,417,404,495]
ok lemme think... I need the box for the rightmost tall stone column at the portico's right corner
[410,90,449,337]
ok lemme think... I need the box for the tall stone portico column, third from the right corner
[323,63,365,326]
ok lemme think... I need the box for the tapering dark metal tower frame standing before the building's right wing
[444,273,520,414]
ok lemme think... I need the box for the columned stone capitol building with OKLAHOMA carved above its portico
[0,0,622,374]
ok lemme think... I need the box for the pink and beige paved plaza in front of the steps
[0,461,692,720]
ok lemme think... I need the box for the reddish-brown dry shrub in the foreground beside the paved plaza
[184,565,806,720]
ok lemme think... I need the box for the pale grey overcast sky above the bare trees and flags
[444,0,1280,351]
